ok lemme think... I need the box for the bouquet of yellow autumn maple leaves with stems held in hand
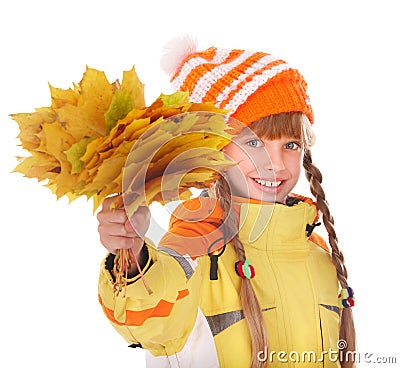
[11,67,232,292]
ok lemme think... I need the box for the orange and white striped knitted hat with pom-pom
[161,36,314,125]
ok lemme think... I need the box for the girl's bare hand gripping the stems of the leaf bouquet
[97,197,150,259]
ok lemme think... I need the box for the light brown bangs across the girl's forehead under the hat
[250,112,315,147]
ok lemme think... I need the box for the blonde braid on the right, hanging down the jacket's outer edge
[303,148,356,368]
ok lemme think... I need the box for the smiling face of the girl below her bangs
[224,128,302,203]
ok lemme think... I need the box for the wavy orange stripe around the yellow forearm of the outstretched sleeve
[99,289,189,326]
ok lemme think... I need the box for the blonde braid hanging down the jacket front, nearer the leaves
[215,177,268,368]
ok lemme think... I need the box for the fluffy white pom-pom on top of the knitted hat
[160,35,197,76]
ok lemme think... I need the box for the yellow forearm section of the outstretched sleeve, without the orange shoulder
[99,242,201,356]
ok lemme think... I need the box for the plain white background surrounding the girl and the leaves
[0,0,400,368]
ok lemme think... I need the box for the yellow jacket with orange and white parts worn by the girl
[99,198,340,368]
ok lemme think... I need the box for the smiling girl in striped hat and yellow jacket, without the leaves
[98,38,355,368]
